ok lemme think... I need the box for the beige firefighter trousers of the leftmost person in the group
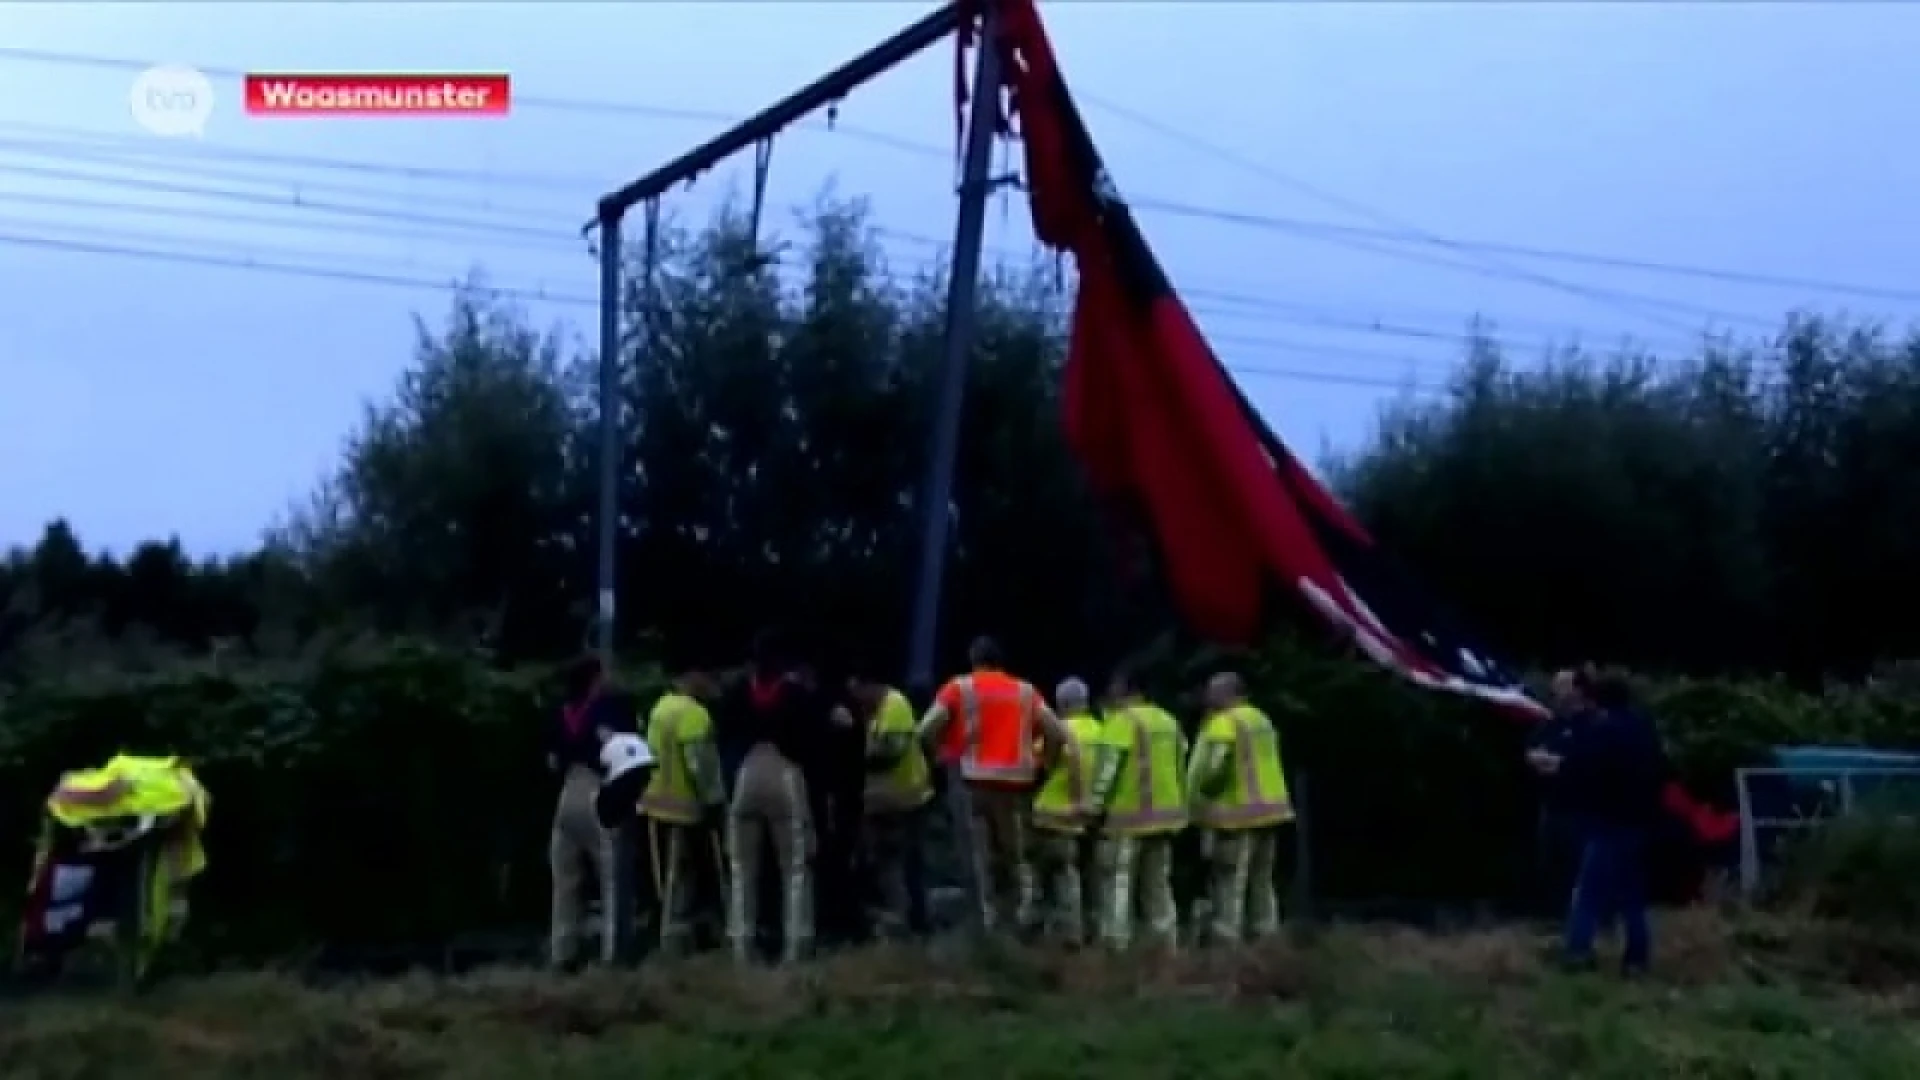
[547,765,634,967]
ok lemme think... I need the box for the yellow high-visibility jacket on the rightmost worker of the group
[1187,705,1294,828]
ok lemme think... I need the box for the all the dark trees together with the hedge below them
[0,202,1920,955]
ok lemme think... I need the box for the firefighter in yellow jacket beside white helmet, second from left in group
[639,667,726,955]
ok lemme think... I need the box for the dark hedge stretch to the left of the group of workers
[0,642,660,951]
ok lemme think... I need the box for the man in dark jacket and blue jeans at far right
[1526,671,1667,974]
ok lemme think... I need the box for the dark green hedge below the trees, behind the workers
[0,642,1920,953]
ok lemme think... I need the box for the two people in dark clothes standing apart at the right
[1526,667,1668,974]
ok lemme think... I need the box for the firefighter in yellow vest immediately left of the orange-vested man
[847,673,933,938]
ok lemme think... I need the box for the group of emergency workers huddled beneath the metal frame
[549,634,1294,967]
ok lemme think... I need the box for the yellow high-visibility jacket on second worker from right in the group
[1094,701,1187,836]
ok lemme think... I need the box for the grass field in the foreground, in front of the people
[0,915,1920,1080]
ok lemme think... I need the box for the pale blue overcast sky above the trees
[0,0,1920,552]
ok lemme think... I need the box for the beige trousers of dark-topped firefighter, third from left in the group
[726,744,814,961]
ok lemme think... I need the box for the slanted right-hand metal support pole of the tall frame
[906,0,1000,932]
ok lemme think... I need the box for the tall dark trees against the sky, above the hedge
[0,200,1920,682]
